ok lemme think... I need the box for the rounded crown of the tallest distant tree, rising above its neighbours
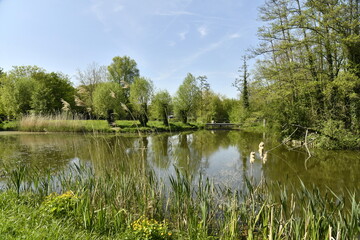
[108,56,140,91]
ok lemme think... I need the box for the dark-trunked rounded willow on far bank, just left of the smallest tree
[130,77,153,126]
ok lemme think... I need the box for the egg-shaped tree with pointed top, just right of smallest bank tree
[174,73,201,123]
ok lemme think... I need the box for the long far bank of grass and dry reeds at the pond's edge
[0,115,204,133]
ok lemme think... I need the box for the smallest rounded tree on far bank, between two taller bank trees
[151,90,172,126]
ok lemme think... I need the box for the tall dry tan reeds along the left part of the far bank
[18,114,112,132]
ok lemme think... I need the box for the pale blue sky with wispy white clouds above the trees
[0,0,264,98]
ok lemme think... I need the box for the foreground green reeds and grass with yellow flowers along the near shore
[0,161,360,239]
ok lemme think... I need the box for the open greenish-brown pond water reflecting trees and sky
[0,131,360,192]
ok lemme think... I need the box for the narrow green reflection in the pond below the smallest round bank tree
[149,133,170,169]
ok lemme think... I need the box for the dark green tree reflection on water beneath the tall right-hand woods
[264,147,360,193]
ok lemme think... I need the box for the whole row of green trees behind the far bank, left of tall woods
[0,56,239,126]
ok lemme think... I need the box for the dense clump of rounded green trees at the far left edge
[0,66,75,118]
